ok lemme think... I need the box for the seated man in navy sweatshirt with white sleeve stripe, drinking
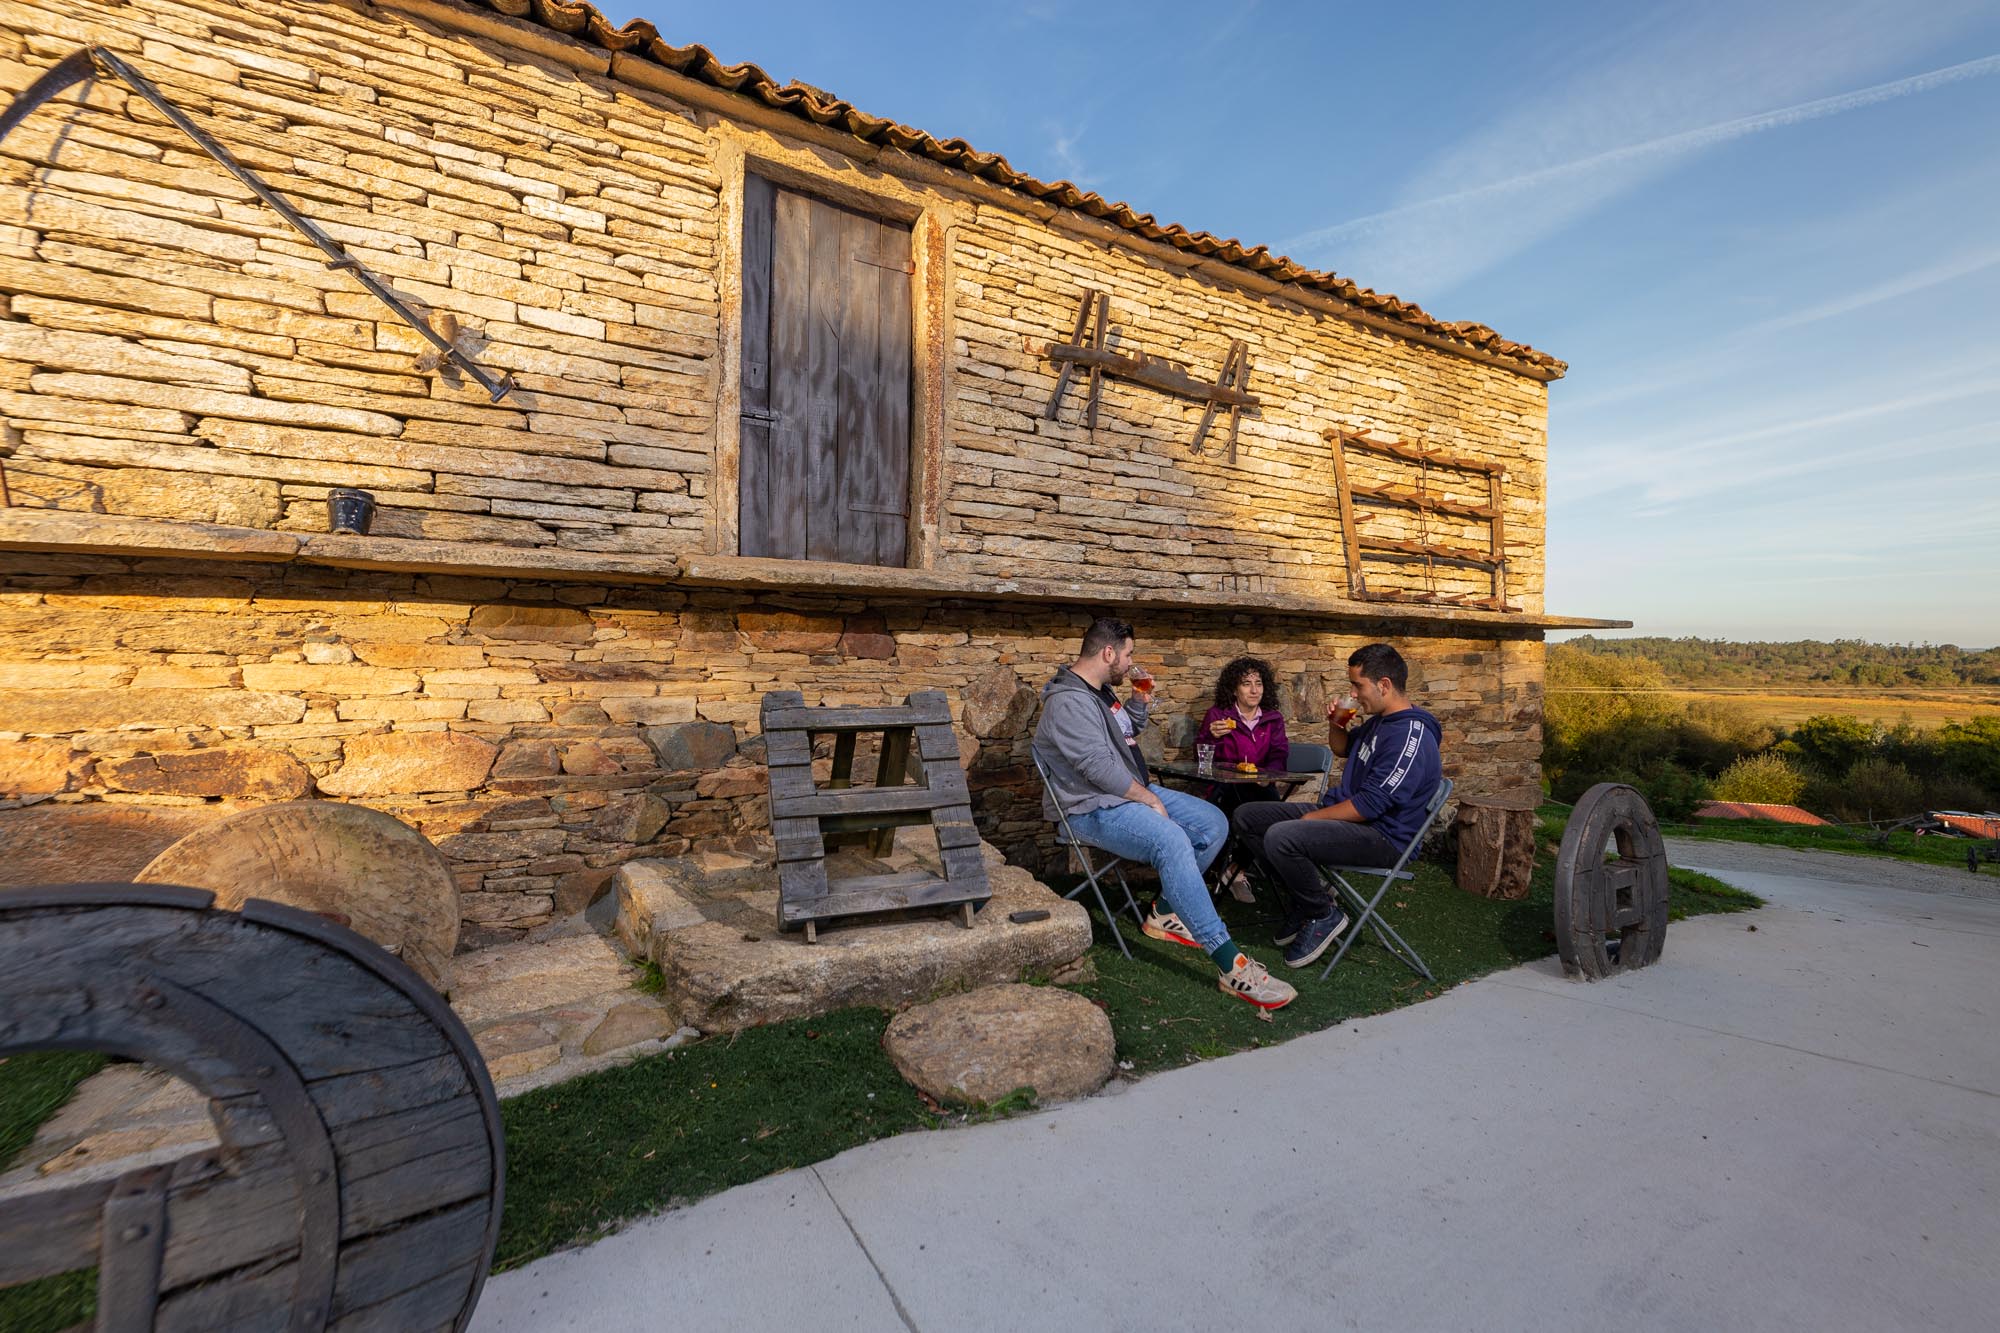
[1234,642,1444,967]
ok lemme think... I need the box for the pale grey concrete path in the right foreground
[474,843,2000,1333]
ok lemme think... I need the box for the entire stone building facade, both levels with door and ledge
[0,0,1604,943]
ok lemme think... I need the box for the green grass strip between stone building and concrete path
[0,849,1758,1304]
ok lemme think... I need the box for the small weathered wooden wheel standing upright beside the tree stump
[1556,783,1666,981]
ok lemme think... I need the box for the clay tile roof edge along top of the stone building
[462,0,1568,378]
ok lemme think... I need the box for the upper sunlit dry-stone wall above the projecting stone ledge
[0,0,1546,610]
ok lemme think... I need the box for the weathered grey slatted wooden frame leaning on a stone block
[760,691,992,941]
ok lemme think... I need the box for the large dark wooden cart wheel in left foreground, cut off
[0,885,504,1331]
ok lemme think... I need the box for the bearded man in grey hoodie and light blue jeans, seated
[1034,618,1298,1009]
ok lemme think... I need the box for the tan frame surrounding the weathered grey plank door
[708,124,952,568]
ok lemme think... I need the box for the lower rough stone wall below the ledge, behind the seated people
[0,556,1542,947]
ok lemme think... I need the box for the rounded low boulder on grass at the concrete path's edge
[882,985,1116,1105]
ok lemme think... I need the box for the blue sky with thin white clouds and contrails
[600,0,2000,646]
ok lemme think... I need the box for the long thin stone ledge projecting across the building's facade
[0,508,1632,630]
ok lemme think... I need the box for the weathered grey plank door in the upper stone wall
[738,176,910,564]
